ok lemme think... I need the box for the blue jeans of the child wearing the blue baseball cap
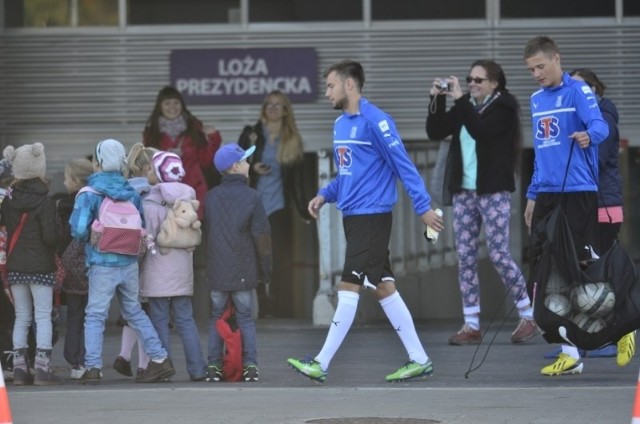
[208,290,258,365]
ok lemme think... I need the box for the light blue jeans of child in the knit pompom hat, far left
[11,284,53,350]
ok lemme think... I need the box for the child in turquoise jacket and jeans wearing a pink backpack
[69,139,175,384]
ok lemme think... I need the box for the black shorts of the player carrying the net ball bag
[531,191,598,261]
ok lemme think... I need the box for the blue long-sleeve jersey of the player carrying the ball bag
[527,73,609,200]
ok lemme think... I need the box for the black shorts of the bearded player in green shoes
[342,212,395,286]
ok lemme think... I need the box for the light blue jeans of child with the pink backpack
[84,262,168,368]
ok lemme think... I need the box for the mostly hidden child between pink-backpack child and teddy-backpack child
[113,143,158,377]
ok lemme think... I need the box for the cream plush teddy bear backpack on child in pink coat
[156,200,202,254]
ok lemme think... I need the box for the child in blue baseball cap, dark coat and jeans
[205,143,271,382]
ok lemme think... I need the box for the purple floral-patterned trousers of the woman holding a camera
[453,191,530,315]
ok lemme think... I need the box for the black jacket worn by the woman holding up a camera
[426,91,521,194]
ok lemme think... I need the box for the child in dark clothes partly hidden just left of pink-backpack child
[58,158,93,380]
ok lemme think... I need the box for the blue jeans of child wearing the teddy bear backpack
[149,296,207,379]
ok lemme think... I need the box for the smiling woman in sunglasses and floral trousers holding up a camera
[426,60,537,345]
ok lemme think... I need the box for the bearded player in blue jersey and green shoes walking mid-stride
[287,60,443,382]
